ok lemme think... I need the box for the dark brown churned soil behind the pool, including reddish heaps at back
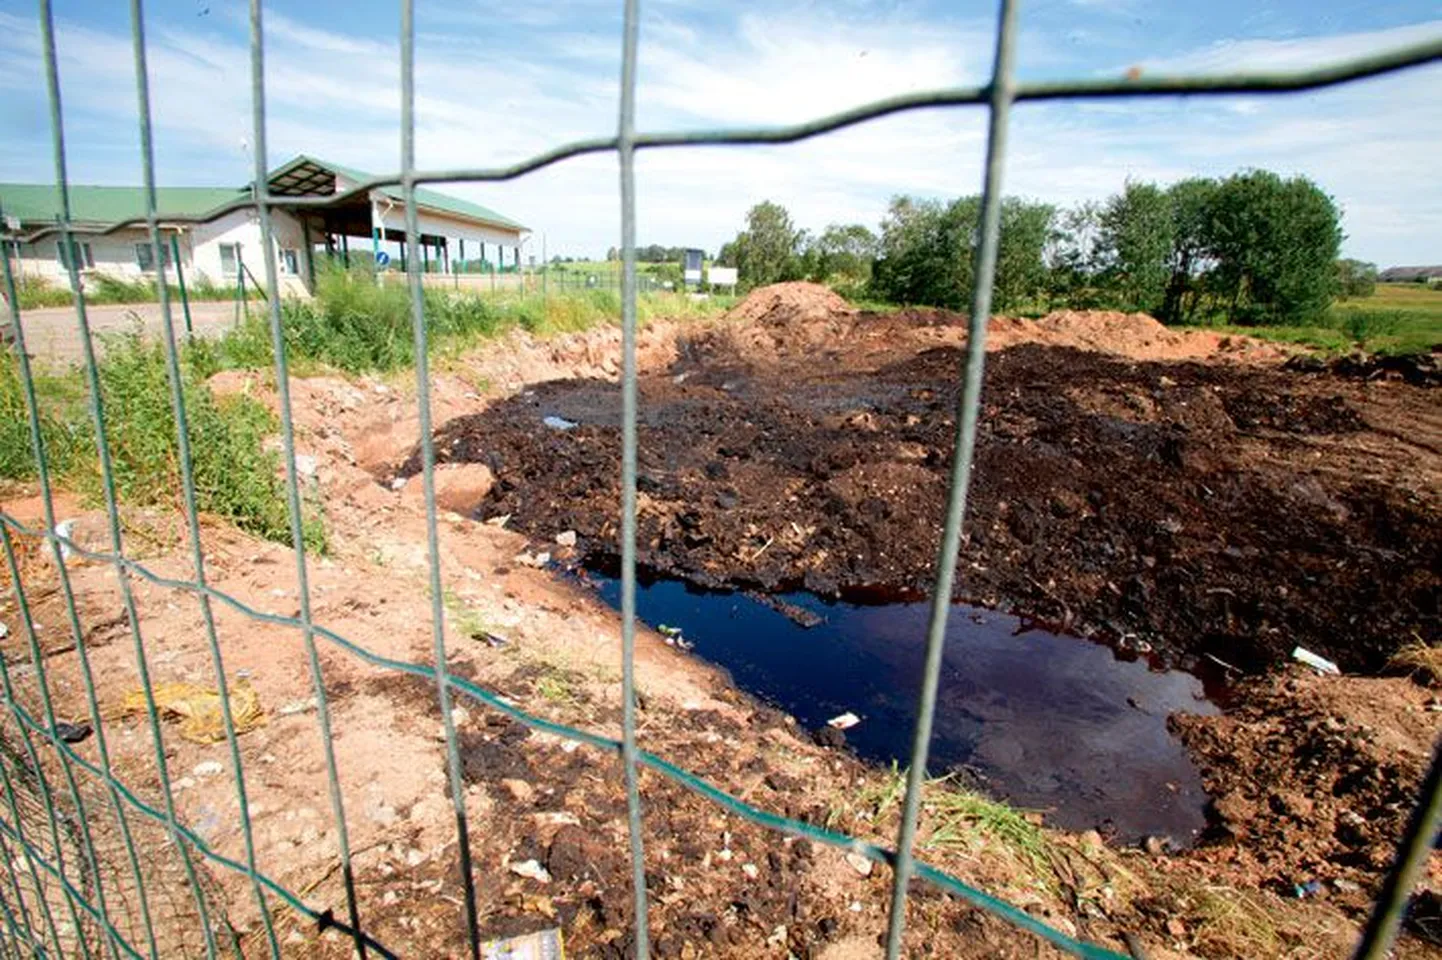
[401,282,1442,670]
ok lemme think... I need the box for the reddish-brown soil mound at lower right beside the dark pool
[1171,669,1442,914]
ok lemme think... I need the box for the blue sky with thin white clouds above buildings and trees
[0,0,1442,267]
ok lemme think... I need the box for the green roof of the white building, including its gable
[0,156,526,231]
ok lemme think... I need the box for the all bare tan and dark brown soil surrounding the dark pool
[0,285,1442,960]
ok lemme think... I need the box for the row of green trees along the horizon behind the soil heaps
[718,170,1377,324]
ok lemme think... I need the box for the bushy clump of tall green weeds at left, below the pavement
[0,334,324,551]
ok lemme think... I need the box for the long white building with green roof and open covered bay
[0,156,528,293]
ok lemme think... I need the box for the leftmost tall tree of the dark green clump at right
[1100,180,1177,310]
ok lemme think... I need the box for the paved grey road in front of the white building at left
[20,300,249,366]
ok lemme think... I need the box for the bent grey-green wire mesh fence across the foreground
[0,0,1442,959]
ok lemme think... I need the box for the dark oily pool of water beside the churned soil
[587,574,1216,845]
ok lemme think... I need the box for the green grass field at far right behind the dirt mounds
[1221,284,1442,353]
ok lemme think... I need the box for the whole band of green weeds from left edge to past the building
[0,262,731,551]
